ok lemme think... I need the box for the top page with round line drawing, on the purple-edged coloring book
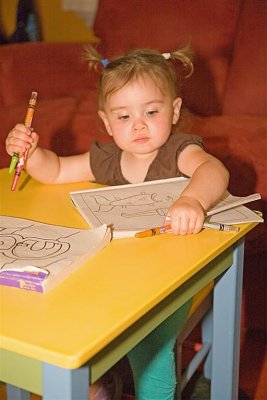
[0,216,111,273]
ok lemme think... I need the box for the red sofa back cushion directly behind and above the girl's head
[94,0,241,115]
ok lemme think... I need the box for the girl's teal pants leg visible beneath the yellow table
[128,300,192,400]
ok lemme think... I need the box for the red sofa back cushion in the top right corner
[223,0,267,115]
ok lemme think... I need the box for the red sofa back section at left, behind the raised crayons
[0,42,96,107]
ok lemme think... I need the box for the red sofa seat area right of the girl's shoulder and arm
[183,114,267,254]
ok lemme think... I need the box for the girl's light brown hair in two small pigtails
[85,46,193,109]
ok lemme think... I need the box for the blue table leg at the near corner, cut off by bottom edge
[43,363,89,400]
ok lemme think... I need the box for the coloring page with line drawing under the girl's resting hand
[71,178,188,232]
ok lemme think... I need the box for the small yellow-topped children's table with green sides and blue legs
[0,169,256,400]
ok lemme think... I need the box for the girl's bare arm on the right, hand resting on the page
[169,145,229,234]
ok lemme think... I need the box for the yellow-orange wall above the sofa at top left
[0,0,97,42]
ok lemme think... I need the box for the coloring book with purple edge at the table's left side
[0,216,111,293]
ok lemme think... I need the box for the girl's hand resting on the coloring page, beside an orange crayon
[164,196,204,235]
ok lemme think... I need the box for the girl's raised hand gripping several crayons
[6,124,39,156]
